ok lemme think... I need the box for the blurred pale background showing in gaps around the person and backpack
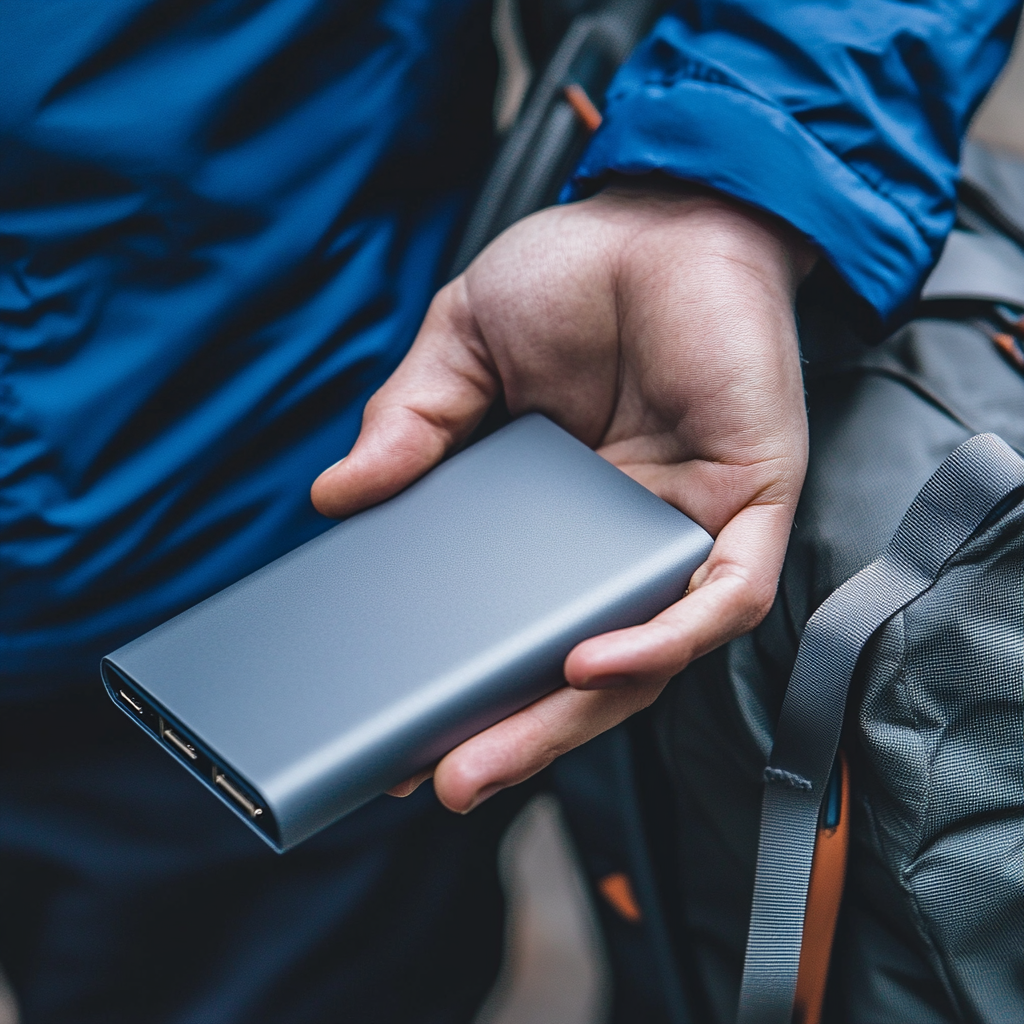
[0,8,1024,1024]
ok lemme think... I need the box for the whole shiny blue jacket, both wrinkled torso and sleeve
[0,0,1016,697]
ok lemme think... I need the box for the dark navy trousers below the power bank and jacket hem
[0,681,521,1024]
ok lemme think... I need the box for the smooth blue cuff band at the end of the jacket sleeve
[562,79,937,327]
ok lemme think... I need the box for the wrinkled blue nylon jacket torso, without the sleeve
[0,0,496,699]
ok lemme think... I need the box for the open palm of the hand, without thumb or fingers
[466,195,805,557]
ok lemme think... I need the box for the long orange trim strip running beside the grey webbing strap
[793,751,850,1024]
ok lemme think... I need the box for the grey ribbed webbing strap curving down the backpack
[737,434,1024,1024]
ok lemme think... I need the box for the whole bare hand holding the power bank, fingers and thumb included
[312,184,815,812]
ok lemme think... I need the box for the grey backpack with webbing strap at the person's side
[738,150,1024,1024]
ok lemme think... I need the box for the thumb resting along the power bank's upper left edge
[310,276,500,518]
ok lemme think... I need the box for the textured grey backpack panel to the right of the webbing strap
[858,509,1024,1021]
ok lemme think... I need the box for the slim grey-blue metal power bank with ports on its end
[101,414,712,852]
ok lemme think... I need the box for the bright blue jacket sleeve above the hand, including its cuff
[571,0,1019,324]
